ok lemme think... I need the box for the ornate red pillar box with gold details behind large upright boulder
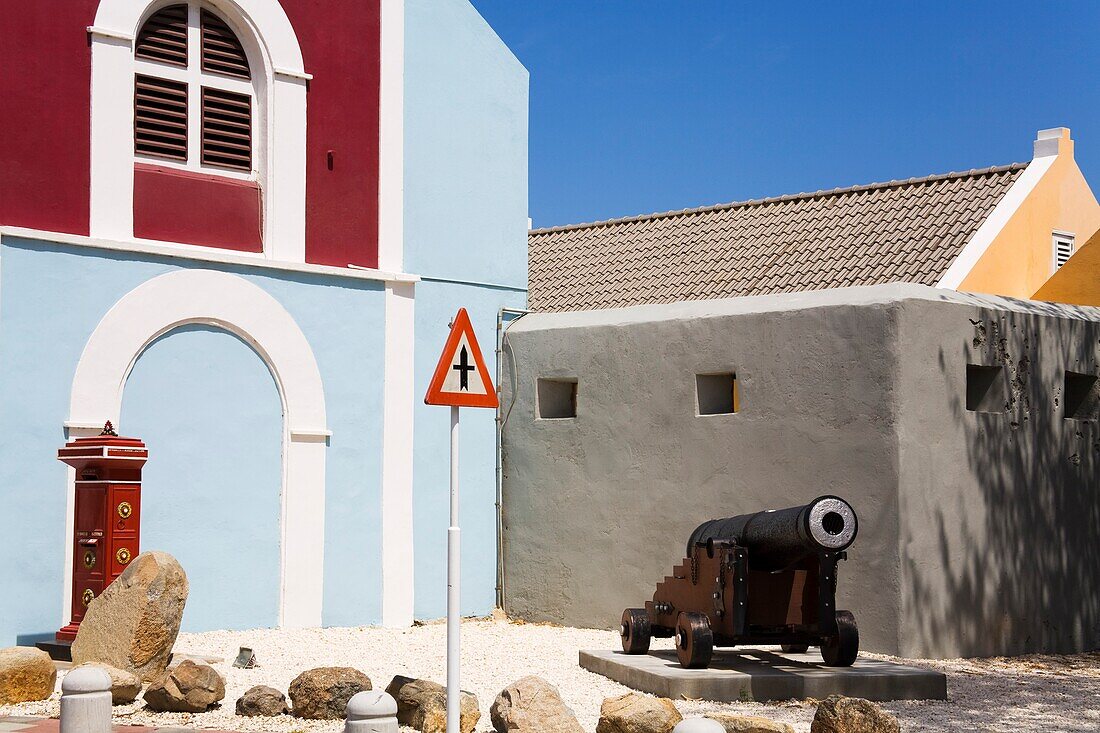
[57,423,149,642]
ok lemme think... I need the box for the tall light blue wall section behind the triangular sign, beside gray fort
[405,0,529,619]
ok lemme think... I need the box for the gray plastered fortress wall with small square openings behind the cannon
[502,285,1100,657]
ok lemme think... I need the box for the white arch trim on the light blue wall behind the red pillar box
[65,270,330,626]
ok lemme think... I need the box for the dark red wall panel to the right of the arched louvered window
[282,0,381,267]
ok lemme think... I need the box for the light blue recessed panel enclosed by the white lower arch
[119,325,283,631]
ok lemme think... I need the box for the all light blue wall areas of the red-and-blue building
[0,0,528,647]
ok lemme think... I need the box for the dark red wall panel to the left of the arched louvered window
[0,0,99,234]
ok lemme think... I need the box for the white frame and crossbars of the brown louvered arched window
[134,0,264,182]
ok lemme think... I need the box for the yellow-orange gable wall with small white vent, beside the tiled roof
[958,130,1100,299]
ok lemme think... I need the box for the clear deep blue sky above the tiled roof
[473,0,1100,227]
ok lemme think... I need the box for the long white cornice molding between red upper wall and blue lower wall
[0,227,420,283]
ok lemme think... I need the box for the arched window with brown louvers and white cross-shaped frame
[134,0,257,175]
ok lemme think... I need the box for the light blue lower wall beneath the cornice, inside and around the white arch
[0,237,385,645]
